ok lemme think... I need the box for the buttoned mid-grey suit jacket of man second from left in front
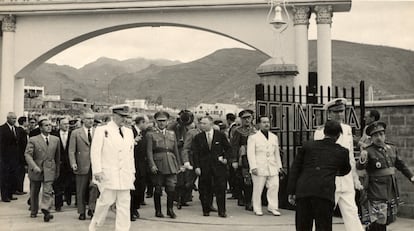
[24,135,60,182]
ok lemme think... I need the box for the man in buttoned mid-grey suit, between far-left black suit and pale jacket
[24,118,60,222]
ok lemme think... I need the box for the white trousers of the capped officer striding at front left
[89,189,131,231]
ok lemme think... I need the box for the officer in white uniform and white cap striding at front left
[89,105,135,231]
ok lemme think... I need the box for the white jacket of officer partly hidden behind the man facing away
[313,123,359,192]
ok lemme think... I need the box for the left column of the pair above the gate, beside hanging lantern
[293,6,310,89]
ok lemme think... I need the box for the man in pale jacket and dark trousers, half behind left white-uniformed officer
[69,113,98,220]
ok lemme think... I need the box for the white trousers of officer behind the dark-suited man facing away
[335,190,364,231]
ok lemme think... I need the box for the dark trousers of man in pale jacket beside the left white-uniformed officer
[76,174,99,214]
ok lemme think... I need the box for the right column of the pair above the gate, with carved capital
[315,6,333,91]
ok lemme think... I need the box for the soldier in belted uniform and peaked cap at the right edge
[356,121,414,231]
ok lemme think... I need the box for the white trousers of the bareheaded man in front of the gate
[252,174,279,213]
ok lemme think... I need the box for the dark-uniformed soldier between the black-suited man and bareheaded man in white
[230,109,256,211]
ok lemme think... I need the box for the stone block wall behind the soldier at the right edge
[365,99,414,219]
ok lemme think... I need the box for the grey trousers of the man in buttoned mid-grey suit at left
[30,180,53,214]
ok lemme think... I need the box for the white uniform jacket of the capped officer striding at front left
[91,121,135,190]
